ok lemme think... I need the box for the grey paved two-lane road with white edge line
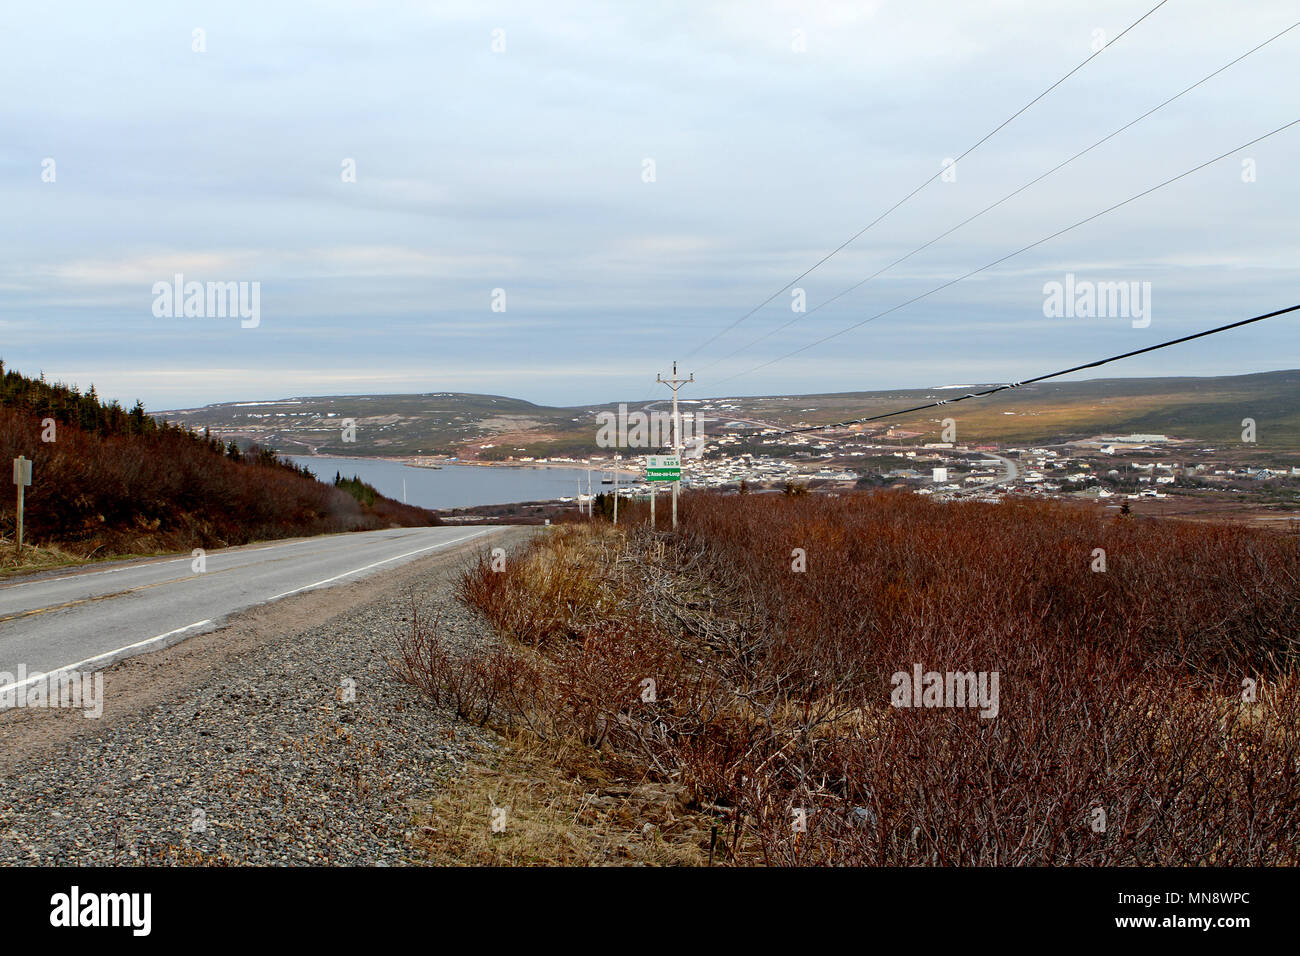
[0,527,497,693]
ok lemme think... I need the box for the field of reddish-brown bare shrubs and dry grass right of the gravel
[407,494,1300,865]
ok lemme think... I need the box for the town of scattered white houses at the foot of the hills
[478,421,1300,519]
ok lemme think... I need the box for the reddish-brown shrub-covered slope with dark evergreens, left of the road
[0,363,437,557]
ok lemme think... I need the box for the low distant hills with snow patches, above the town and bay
[163,369,1300,459]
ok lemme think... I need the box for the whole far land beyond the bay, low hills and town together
[165,371,1300,527]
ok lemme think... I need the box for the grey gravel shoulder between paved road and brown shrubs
[0,528,536,865]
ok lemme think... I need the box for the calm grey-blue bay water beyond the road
[286,455,598,509]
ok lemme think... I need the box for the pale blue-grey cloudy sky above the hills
[0,0,1300,410]
